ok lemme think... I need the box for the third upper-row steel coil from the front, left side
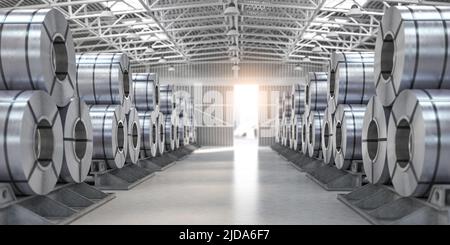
[132,73,160,112]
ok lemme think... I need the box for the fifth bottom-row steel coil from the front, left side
[139,111,159,158]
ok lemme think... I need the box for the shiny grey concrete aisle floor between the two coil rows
[74,140,367,225]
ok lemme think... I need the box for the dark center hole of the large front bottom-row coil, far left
[34,119,54,167]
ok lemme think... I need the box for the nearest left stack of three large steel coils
[0,9,93,195]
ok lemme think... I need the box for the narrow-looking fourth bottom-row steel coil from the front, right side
[321,108,334,164]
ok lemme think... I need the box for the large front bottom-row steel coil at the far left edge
[0,91,64,195]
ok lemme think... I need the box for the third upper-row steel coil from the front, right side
[305,72,328,111]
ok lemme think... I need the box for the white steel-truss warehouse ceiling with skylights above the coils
[0,0,448,65]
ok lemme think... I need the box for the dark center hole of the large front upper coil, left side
[52,36,69,81]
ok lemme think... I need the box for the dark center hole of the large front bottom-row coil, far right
[395,119,411,168]
